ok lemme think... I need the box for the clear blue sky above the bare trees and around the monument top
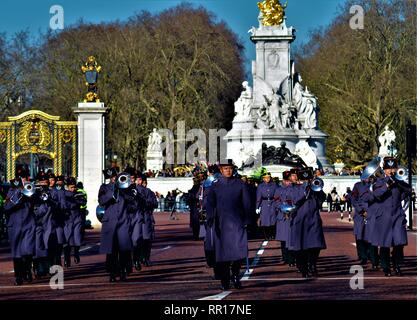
[0,0,346,72]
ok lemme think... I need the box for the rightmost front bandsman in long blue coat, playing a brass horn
[370,157,411,277]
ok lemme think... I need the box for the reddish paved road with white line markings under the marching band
[0,212,417,300]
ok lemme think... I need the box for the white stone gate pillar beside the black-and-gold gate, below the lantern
[73,102,107,226]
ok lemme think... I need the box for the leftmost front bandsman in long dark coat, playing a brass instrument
[4,172,36,285]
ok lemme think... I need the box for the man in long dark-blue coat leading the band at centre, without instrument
[207,159,251,290]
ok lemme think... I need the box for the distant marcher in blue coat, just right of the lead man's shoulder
[256,172,278,240]
